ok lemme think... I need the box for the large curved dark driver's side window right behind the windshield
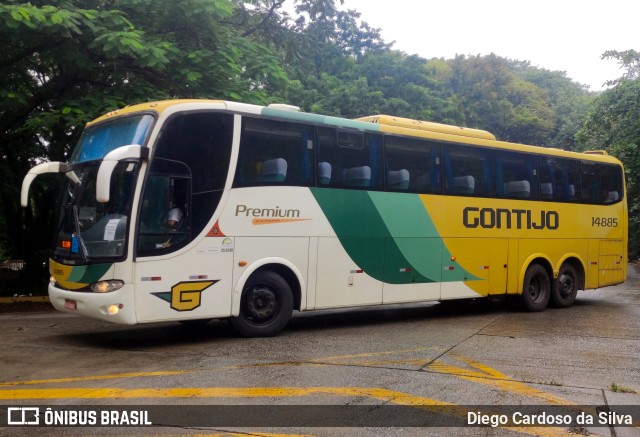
[138,112,233,256]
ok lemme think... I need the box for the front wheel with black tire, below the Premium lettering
[230,270,293,337]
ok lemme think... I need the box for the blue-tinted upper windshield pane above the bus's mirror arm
[69,114,154,164]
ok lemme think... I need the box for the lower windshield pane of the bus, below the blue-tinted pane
[53,162,139,264]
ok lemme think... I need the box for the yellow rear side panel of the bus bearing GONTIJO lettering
[420,195,627,295]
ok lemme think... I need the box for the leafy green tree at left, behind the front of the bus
[0,0,286,290]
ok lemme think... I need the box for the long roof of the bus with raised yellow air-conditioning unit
[87,99,620,164]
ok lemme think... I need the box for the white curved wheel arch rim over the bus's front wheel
[231,257,306,317]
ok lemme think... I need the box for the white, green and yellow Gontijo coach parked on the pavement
[21,100,628,337]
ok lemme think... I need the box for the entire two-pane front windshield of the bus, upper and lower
[53,114,154,264]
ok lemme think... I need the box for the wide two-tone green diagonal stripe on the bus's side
[311,188,478,284]
